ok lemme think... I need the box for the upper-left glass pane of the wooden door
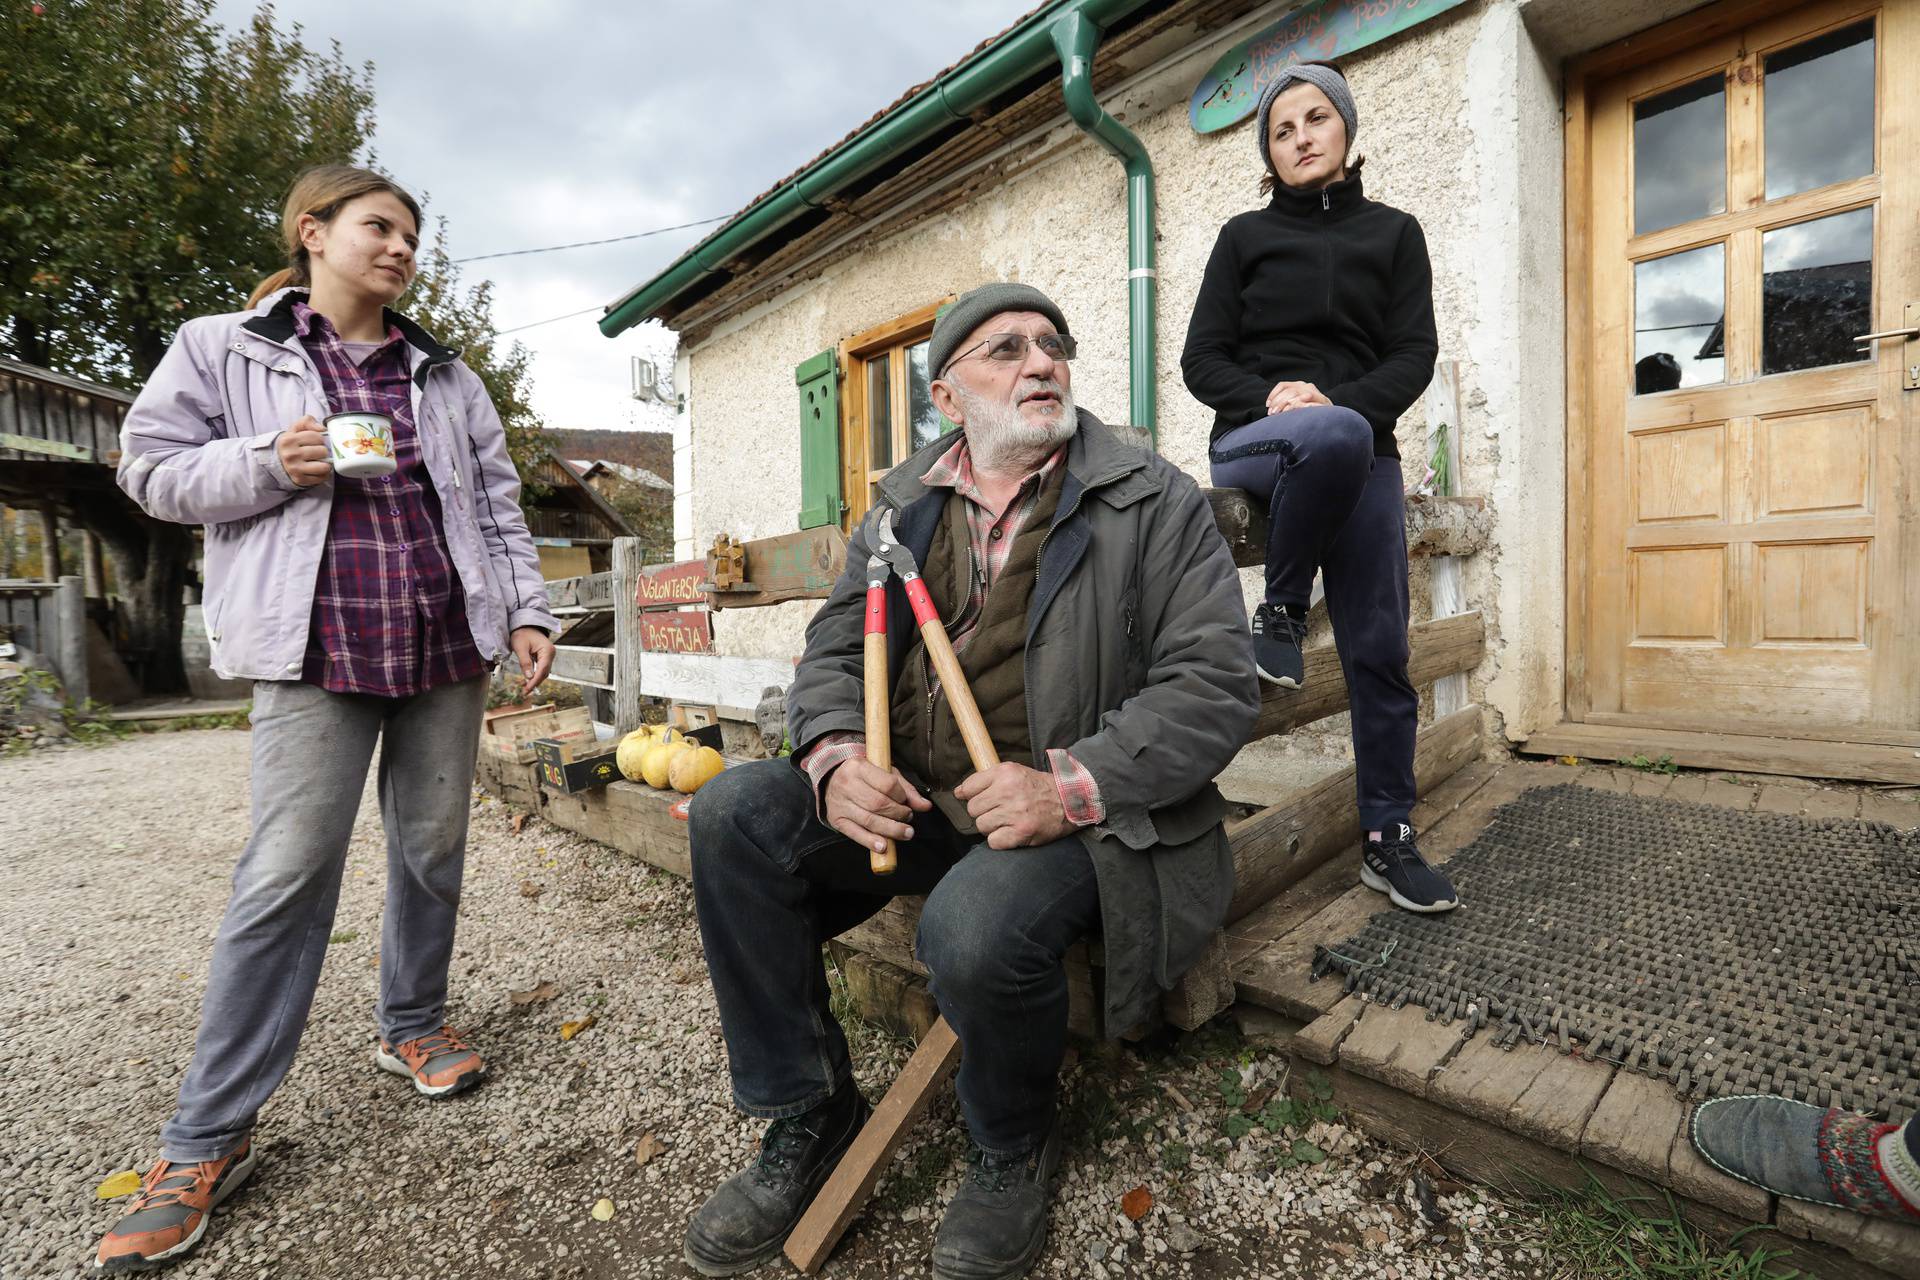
[1634,73,1726,234]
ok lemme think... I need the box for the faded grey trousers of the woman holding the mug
[159,676,488,1163]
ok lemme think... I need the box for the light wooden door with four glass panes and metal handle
[1569,0,1920,743]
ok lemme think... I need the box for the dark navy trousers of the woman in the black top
[1208,405,1419,831]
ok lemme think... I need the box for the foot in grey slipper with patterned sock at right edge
[1688,1096,1920,1222]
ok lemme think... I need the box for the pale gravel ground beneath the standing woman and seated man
[0,731,1549,1280]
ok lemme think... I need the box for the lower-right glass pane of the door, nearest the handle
[1761,209,1874,374]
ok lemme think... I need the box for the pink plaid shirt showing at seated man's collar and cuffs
[801,436,1106,827]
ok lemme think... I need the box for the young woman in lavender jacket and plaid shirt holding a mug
[94,165,557,1270]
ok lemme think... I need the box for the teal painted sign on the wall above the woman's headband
[1187,0,1465,132]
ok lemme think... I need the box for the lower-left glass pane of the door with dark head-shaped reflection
[1634,244,1726,395]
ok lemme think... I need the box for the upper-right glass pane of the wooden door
[1764,19,1874,200]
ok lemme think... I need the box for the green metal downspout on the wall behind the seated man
[1050,8,1160,445]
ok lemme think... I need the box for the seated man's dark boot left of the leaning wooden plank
[682,1084,874,1276]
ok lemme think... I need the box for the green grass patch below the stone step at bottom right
[1523,1174,1811,1280]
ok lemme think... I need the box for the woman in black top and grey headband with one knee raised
[1181,63,1459,912]
